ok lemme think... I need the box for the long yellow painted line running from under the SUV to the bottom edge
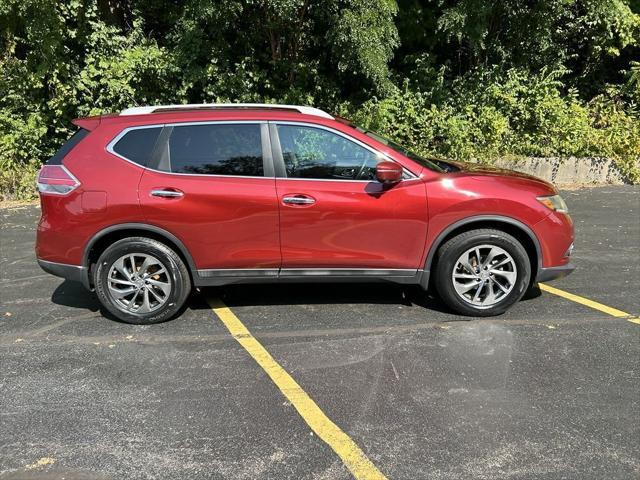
[207,299,386,480]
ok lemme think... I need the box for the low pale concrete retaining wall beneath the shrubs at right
[494,157,631,185]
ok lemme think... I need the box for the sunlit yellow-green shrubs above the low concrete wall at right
[352,66,640,182]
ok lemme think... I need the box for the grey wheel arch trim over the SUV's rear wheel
[82,223,197,282]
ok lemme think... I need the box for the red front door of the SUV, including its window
[269,122,427,276]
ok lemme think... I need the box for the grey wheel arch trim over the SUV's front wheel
[421,215,542,288]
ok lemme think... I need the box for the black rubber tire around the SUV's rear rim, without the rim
[93,237,191,325]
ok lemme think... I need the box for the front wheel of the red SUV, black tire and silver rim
[435,229,531,317]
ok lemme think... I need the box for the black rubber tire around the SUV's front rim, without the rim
[434,229,531,317]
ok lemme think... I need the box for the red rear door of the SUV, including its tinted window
[134,122,281,277]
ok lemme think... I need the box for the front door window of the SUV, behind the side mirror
[278,125,383,180]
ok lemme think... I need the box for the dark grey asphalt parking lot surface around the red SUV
[0,186,640,479]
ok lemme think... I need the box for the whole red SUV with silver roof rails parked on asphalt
[36,104,573,324]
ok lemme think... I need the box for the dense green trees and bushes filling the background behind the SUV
[0,0,640,198]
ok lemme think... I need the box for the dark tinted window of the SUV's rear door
[168,123,264,177]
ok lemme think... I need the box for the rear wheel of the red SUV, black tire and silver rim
[94,237,191,325]
